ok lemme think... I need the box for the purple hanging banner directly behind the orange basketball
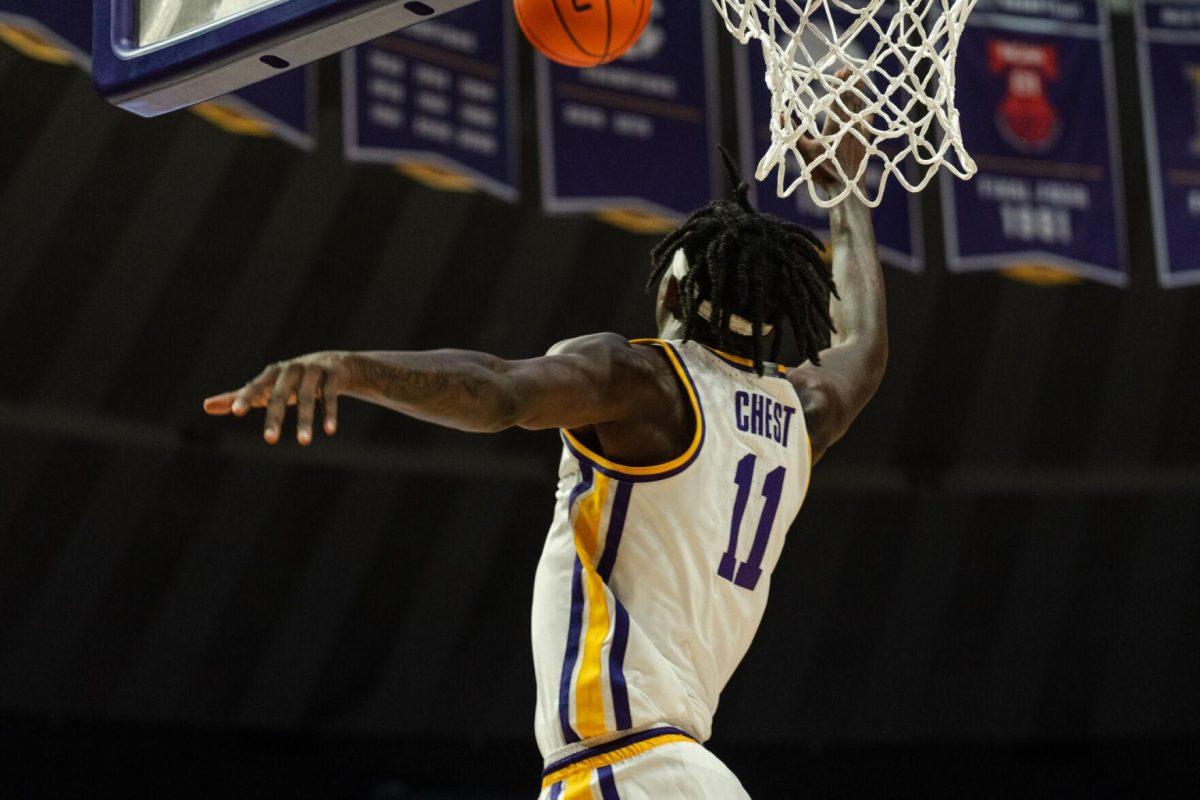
[534,2,720,231]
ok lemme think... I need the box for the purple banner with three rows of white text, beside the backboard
[342,2,520,200]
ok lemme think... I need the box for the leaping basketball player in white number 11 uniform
[205,76,888,800]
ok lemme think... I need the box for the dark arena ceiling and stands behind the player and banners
[0,0,1200,800]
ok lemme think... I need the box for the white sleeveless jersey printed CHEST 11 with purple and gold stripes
[533,339,812,764]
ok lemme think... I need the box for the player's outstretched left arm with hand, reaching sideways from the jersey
[204,333,678,445]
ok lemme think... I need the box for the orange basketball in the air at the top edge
[512,0,652,67]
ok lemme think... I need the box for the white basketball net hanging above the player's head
[713,0,976,207]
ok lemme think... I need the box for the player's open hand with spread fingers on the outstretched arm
[204,351,350,445]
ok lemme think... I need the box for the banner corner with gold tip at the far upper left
[0,0,91,70]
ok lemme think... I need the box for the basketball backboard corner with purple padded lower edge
[92,0,475,116]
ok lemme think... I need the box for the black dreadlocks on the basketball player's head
[646,148,838,375]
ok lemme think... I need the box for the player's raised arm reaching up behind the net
[788,72,888,458]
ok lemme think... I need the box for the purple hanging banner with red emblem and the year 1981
[941,0,1128,285]
